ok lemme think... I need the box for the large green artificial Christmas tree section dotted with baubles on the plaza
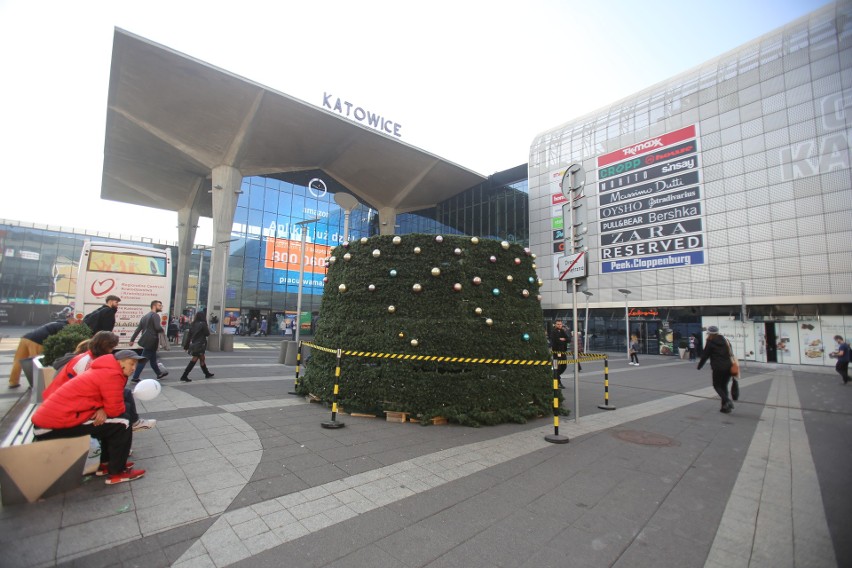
[299,234,561,426]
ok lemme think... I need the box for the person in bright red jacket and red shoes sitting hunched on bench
[32,350,145,485]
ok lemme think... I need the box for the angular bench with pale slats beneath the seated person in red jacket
[0,357,89,505]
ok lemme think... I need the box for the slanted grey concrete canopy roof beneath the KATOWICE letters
[101,29,486,217]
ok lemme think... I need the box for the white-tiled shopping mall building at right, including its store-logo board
[530,2,852,360]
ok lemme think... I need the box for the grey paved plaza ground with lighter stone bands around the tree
[0,328,852,568]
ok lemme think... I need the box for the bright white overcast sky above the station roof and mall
[0,0,828,244]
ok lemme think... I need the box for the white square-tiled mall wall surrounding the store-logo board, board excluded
[529,2,852,309]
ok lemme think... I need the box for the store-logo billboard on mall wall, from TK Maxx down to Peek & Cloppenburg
[596,125,706,274]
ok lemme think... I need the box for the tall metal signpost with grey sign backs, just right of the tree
[557,162,589,422]
